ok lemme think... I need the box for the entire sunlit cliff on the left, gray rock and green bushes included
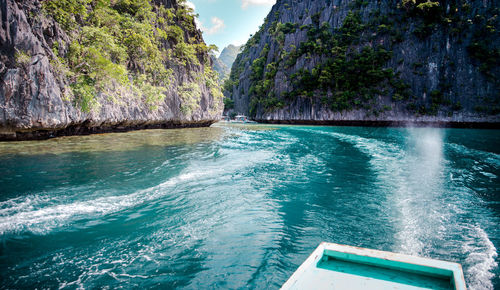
[0,0,223,140]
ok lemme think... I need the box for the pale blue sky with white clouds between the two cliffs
[189,0,276,51]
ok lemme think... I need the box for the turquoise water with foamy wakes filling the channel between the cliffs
[0,124,500,289]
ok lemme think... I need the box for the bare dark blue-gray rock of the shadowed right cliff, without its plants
[225,0,500,124]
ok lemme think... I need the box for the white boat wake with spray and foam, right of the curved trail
[298,128,499,289]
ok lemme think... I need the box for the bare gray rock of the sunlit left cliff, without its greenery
[0,0,223,140]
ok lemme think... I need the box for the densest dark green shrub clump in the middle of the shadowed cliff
[286,12,407,111]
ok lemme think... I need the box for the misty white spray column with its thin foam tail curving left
[337,130,448,255]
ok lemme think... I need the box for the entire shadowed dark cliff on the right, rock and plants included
[224,0,500,123]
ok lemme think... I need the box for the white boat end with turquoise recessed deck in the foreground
[281,243,466,290]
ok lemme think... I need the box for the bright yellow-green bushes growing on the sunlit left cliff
[43,0,221,114]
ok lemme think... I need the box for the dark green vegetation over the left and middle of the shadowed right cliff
[241,12,409,115]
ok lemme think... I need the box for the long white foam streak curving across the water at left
[0,151,273,235]
